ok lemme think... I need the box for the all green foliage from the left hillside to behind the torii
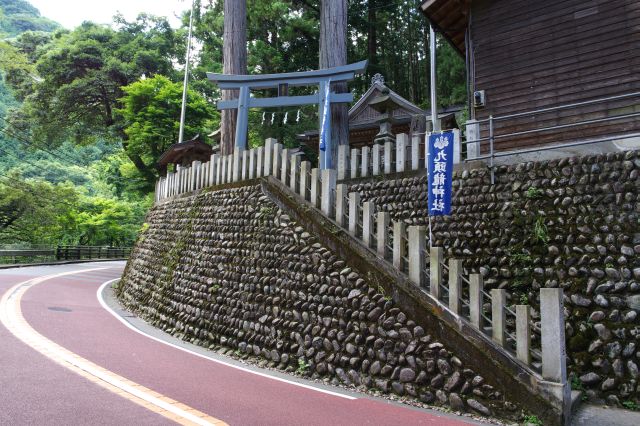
[0,0,466,250]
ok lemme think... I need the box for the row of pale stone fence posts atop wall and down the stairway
[156,135,566,384]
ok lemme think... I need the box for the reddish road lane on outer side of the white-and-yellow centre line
[0,266,173,425]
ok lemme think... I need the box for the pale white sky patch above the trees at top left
[28,0,191,29]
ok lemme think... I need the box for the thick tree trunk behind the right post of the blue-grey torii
[320,0,349,165]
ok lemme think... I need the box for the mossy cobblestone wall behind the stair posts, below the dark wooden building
[347,151,640,406]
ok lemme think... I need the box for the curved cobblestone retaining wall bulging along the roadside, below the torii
[118,185,520,417]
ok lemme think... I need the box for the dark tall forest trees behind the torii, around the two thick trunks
[190,0,466,151]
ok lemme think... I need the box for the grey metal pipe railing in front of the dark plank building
[462,92,640,183]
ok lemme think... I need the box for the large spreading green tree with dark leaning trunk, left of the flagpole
[15,15,181,185]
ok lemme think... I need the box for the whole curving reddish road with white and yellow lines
[0,262,475,425]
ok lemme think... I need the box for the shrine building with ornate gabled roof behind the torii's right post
[298,74,461,151]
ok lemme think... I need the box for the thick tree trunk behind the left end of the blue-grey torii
[220,0,247,155]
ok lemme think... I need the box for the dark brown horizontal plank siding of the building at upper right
[470,0,640,149]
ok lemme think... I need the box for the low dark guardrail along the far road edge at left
[0,246,131,263]
